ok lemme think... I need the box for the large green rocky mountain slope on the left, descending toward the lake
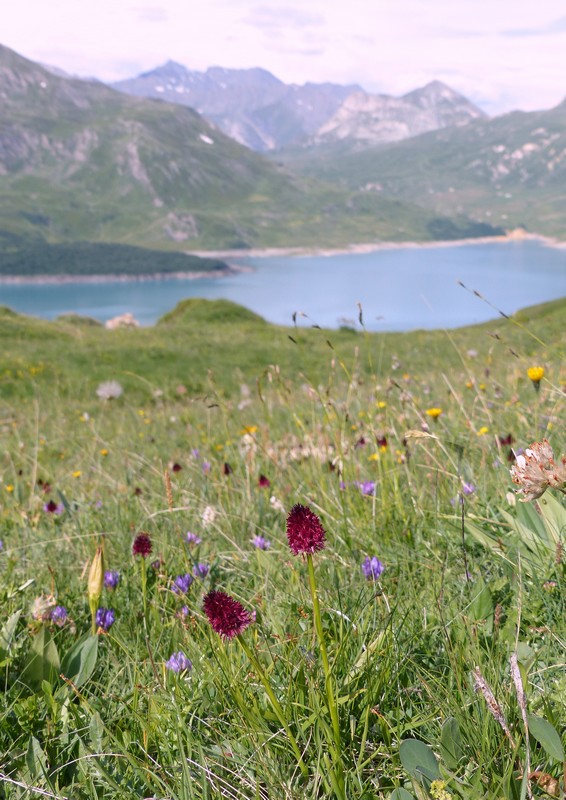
[0,41,506,250]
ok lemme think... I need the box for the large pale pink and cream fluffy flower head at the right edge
[510,439,566,502]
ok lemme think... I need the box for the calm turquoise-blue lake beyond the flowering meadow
[0,241,566,331]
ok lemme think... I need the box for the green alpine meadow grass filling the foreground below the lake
[0,300,566,800]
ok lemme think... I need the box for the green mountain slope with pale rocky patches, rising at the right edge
[277,101,566,238]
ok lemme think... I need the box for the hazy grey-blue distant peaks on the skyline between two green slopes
[113,61,486,152]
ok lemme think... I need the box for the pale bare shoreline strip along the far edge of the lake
[0,232,566,286]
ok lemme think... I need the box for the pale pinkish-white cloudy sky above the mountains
[4,0,566,114]
